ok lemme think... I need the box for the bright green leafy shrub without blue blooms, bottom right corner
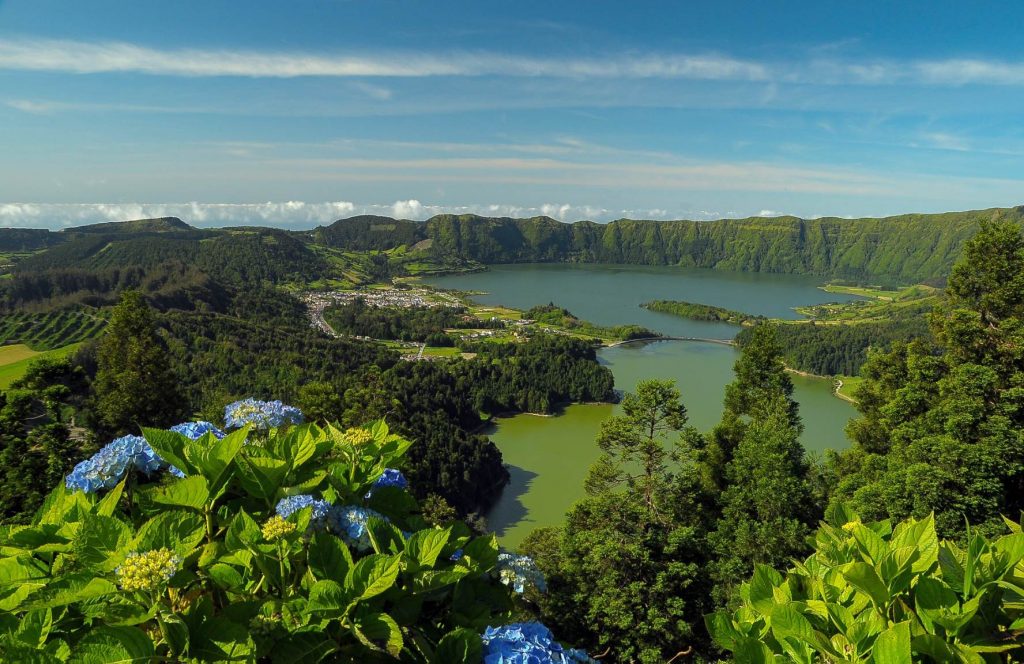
[707,506,1024,663]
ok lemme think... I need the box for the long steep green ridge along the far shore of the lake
[314,206,1024,283]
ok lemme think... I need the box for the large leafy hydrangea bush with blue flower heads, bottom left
[0,409,582,664]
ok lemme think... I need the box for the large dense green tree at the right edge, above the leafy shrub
[833,222,1024,536]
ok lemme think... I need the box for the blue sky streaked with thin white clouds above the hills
[0,0,1024,227]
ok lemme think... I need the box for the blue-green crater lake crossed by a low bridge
[426,264,856,547]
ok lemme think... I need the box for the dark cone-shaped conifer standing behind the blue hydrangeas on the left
[93,291,185,435]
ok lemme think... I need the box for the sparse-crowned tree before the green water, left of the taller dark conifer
[522,380,710,662]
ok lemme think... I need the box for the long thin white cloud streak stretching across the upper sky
[0,37,1024,90]
